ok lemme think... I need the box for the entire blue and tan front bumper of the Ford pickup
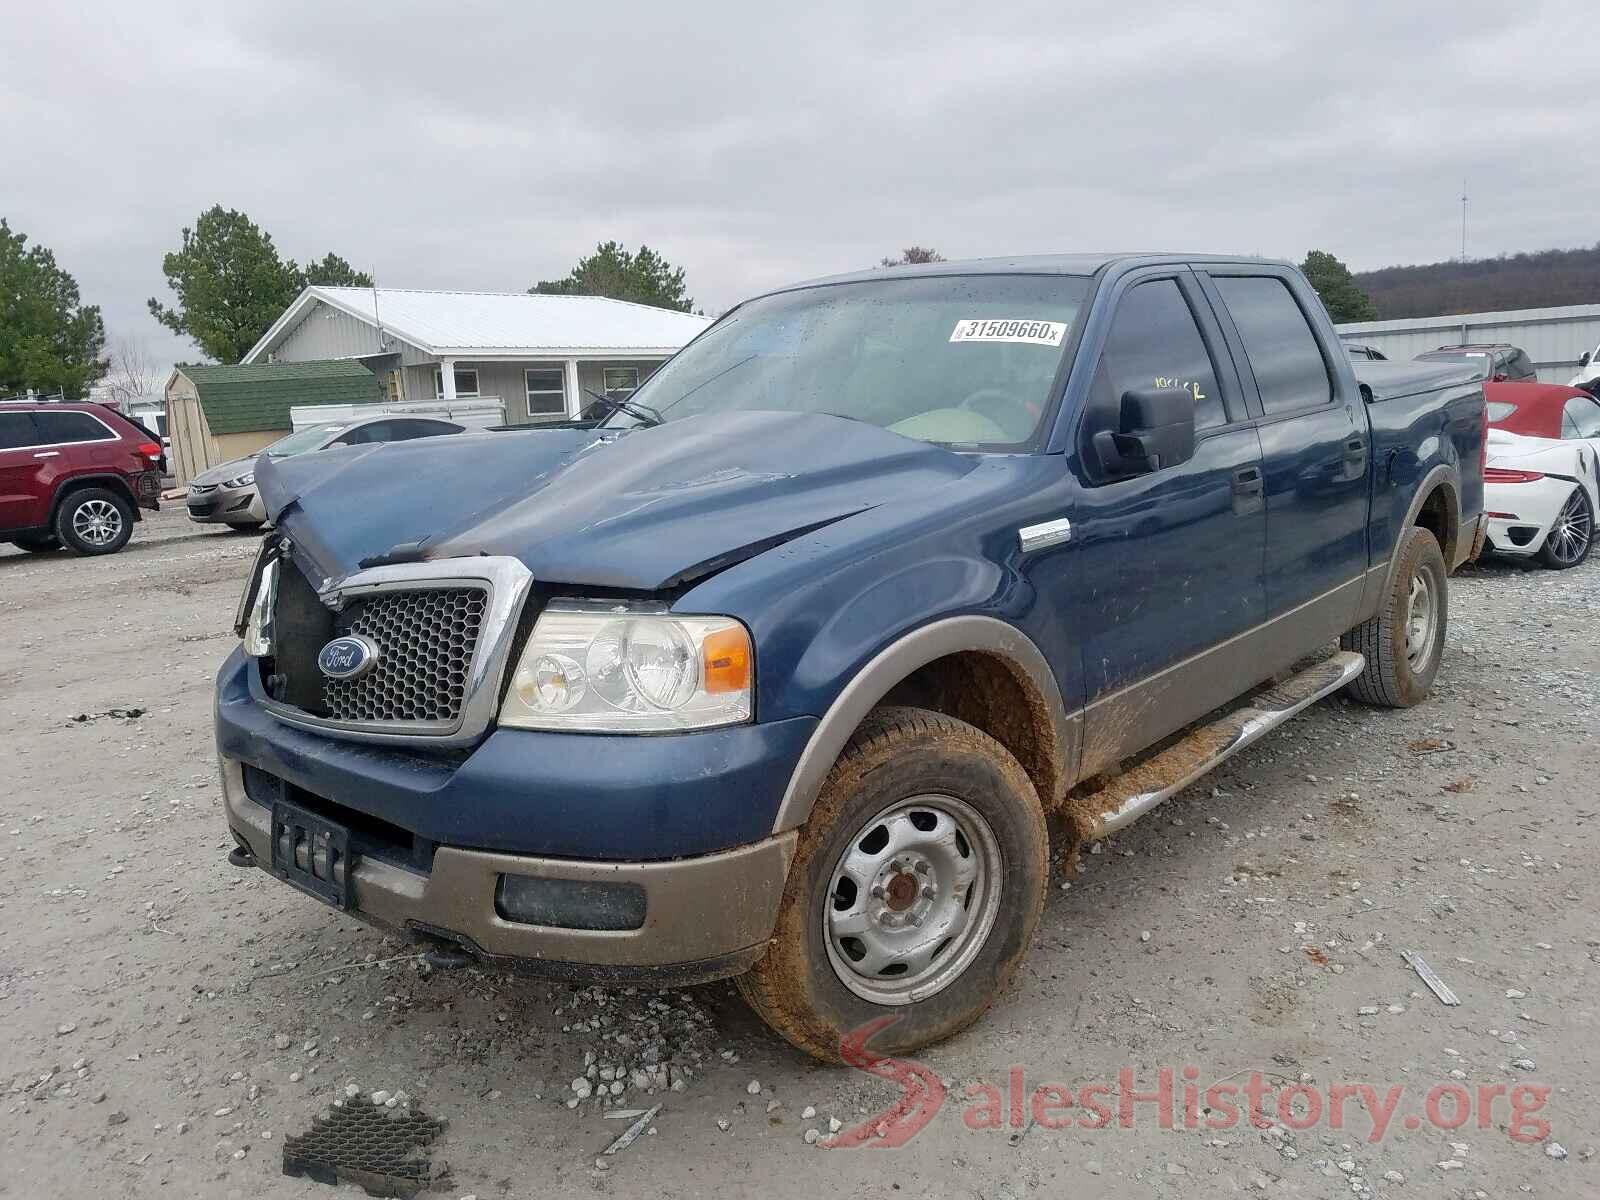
[216,651,816,986]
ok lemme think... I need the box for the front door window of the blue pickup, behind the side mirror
[1093,278,1227,430]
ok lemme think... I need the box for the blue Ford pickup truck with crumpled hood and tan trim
[216,254,1485,1059]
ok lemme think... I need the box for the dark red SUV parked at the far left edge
[0,403,162,554]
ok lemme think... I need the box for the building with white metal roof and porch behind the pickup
[243,286,710,424]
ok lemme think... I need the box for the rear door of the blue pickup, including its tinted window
[1203,266,1371,646]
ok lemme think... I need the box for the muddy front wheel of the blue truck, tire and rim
[738,707,1050,1062]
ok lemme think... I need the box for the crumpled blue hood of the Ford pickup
[256,411,976,592]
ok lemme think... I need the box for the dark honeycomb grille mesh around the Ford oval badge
[323,587,488,723]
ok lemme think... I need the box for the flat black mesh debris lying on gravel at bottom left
[283,1101,450,1197]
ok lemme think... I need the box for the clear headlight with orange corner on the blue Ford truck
[501,600,755,733]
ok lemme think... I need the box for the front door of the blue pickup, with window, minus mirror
[1064,269,1266,774]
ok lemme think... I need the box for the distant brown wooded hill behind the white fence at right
[1355,245,1600,320]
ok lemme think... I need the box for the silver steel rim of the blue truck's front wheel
[821,795,1005,1005]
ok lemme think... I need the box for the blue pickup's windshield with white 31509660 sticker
[606,275,1090,448]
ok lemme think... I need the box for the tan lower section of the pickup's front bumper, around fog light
[221,757,797,986]
